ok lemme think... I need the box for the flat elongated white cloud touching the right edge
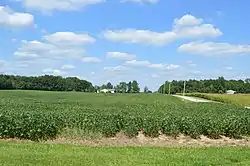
[178,42,250,56]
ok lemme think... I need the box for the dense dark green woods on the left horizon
[0,75,95,92]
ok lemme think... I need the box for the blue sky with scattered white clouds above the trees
[0,0,250,90]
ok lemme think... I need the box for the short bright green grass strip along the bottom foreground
[0,142,250,166]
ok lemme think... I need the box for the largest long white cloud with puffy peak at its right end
[103,15,222,46]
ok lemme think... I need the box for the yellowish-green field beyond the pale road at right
[189,93,250,107]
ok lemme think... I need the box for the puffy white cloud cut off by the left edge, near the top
[0,6,34,28]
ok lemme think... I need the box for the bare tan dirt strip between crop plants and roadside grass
[44,133,250,148]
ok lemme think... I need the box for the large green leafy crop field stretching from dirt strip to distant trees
[0,91,250,141]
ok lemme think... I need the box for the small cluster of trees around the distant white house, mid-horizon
[95,80,140,93]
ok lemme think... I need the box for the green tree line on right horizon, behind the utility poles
[158,77,250,93]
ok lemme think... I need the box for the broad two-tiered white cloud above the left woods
[14,32,95,60]
